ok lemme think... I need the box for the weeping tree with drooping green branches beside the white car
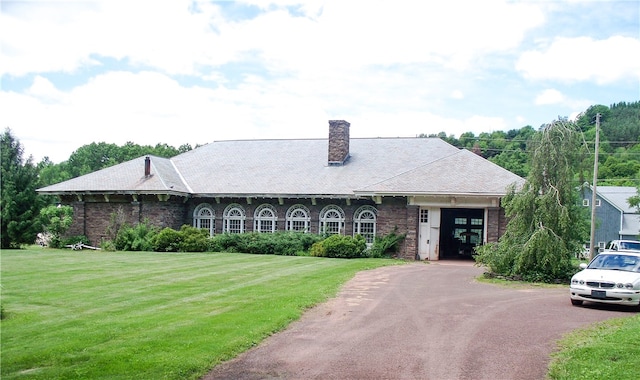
[476,120,589,282]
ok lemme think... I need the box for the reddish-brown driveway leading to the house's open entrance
[205,261,634,380]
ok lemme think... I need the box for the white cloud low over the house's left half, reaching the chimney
[0,72,330,162]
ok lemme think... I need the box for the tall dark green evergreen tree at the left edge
[0,128,42,249]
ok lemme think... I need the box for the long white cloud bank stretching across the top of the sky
[0,0,544,75]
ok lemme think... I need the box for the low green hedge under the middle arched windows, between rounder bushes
[209,232,322,256]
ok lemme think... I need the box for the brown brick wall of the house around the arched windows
[63,195,506,260]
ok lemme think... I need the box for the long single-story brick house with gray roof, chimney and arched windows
[38,120,524,260]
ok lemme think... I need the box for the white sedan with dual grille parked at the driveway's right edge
[569,251,640,309]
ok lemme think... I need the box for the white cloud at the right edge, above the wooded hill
[516,36,640,84]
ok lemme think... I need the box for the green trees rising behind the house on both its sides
[0,101,640,252]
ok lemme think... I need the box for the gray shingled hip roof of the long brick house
[39,138,522,197]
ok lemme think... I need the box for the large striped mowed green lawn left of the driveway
[1,248,398,379]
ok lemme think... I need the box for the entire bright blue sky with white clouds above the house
[0,0,640,163]
